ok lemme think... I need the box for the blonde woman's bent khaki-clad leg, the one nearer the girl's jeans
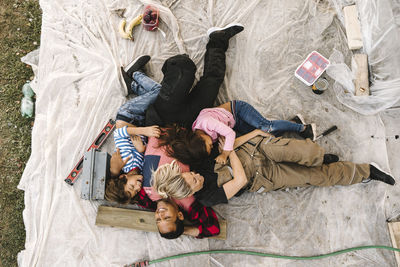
[259,137,324,167]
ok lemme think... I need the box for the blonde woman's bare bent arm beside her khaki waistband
[222,151,247,199]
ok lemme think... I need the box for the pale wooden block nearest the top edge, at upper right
[343,5,363,50]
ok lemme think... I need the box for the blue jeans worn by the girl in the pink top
[231,100,304,135]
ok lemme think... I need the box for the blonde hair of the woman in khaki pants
[152,160,193,199]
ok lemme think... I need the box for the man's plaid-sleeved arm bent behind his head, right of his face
[185,201,220,238]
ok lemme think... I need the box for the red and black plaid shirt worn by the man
[137,188,219,238]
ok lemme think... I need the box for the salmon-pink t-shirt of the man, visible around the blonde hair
[143,137,194,211]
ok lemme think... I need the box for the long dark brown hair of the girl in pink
[159,126,208,168]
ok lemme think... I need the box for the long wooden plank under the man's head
[96,206,227,240]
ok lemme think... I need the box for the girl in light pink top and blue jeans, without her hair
[192,100,315,164]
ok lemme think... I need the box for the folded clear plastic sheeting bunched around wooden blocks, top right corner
[327,0,400,115]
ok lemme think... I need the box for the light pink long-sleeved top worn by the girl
[192,108,236,151]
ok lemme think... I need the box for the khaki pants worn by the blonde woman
[215,137,369,193]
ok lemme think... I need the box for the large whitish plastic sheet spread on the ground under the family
[18,0,400,267]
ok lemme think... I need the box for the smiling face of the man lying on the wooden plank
[154,200,183,234]
